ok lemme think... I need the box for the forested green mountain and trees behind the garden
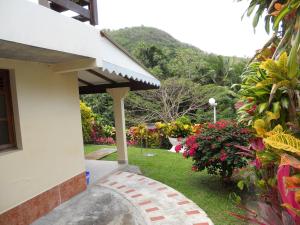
[82,26,247,126]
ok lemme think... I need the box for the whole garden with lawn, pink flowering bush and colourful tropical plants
[80,0,300,225]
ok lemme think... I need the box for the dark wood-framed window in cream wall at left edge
[0,69,16,150]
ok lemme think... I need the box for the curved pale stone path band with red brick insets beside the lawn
[100,172,213,225]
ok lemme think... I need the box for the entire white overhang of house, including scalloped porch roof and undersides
[0,0,160,94]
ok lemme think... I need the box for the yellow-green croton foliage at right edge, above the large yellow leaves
[238,52,300,129]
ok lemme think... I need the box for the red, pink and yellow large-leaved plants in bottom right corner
[230,119,300,225]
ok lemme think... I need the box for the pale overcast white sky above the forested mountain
[31,0,269,57]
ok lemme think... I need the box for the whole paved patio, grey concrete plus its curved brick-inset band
[33,169,213,225]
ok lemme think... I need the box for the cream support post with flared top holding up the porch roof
[106,87,130,164]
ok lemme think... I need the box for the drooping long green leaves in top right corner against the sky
[238,0,300,61]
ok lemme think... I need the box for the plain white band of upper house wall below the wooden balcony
[0,0,102,66]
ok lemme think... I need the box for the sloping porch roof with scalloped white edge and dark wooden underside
[78,32,160,94]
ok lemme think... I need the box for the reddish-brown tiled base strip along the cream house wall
[0,172,87,225]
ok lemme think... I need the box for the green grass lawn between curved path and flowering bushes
[83,146,244,225]
